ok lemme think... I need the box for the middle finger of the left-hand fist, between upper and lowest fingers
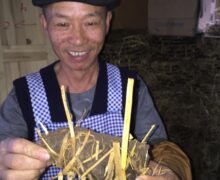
[2,153,47,170]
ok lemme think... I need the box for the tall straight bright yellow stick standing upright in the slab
[121,78,134,179]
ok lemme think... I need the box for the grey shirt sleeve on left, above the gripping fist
[0,88,28,141]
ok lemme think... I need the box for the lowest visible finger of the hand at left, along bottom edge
[0,170,42,180]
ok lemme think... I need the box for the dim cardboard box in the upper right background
[148,0,199,36]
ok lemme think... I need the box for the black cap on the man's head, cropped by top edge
[32,0,119,10]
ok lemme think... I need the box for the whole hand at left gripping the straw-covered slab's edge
[0,138,50,180]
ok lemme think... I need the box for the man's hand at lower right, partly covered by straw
[136,161,180,180]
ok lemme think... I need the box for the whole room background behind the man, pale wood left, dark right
[0,0,220,180]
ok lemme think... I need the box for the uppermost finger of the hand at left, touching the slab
[1,138,50,161]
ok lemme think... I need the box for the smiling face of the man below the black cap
[41,2,111,70]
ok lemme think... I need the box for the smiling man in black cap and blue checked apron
[0,0,191,180]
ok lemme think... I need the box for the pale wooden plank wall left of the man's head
[0,0,54,103]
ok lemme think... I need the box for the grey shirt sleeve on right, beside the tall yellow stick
[134,76,167,144]
